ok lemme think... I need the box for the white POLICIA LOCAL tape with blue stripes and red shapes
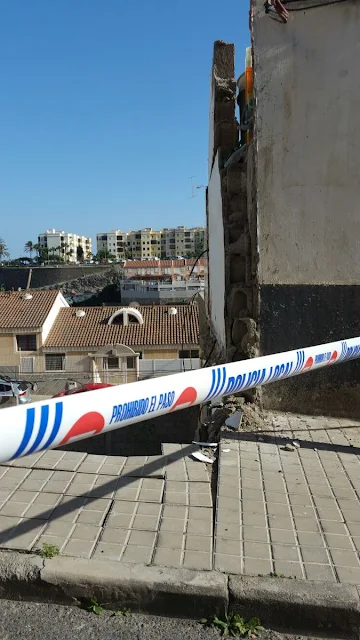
[0,337,360,462]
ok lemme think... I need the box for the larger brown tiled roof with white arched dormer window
[44,304,199,347]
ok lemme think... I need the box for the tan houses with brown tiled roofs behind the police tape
[0,290,200,395]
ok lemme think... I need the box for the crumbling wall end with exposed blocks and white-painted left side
[207,41,258,378]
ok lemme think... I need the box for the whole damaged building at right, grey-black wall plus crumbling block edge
[207,0,360,417]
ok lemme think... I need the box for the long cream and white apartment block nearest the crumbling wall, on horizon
[96,227,205,260]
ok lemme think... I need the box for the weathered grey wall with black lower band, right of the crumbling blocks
[252,0,360,415]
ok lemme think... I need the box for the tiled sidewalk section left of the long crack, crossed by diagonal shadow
[0,444,213,570]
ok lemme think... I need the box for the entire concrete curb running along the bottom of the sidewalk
[0,551,360,634]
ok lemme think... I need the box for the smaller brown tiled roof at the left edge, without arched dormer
[0,290,59,331]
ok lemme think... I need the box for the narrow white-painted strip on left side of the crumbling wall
[208,152,226,348]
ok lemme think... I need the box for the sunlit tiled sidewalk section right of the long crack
[214,414,360,584]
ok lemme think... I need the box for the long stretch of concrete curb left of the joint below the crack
[0,552,228,620]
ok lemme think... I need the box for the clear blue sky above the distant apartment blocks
[0,0,249,257]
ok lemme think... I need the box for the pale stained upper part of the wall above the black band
[253,0,360,284]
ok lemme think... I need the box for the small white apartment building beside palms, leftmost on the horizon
[38,229,92,262]
